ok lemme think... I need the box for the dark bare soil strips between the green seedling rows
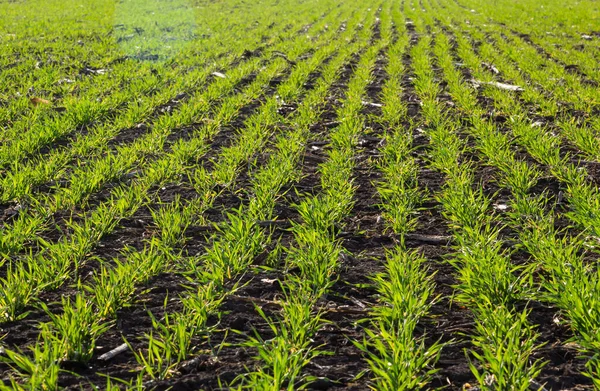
[0,8,600,391]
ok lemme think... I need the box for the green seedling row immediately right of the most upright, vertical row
[406,9,544,390]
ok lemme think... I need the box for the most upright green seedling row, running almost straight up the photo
[354,9,442,390]
